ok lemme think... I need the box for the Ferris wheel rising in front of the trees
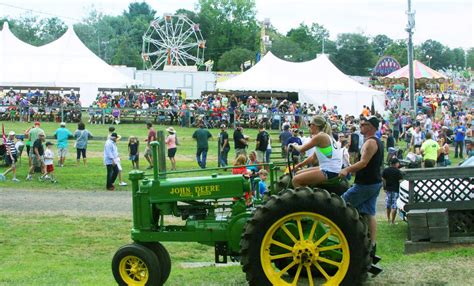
[142,14,206,70]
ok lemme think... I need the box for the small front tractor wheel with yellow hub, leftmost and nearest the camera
[112,243,162,286]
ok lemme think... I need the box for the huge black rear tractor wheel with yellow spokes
[240,188,371,285]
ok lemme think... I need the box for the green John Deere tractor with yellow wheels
[112,139,380,285]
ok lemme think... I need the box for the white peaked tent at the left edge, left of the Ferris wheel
[0,22,136,105]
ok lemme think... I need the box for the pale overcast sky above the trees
[0,0,474,48]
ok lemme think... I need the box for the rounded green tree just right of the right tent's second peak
[332,33,377,75]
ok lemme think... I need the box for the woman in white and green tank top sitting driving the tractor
[291,116,342,188]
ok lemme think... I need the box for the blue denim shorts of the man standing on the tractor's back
[342,182,382,216]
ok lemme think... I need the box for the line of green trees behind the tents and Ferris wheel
[0,0,474,75]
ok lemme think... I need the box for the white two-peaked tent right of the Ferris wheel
[217,52,384,115]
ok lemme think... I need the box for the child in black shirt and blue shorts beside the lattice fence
[382,158,403,224]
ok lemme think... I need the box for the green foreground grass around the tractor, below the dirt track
[0,213,474,286]
